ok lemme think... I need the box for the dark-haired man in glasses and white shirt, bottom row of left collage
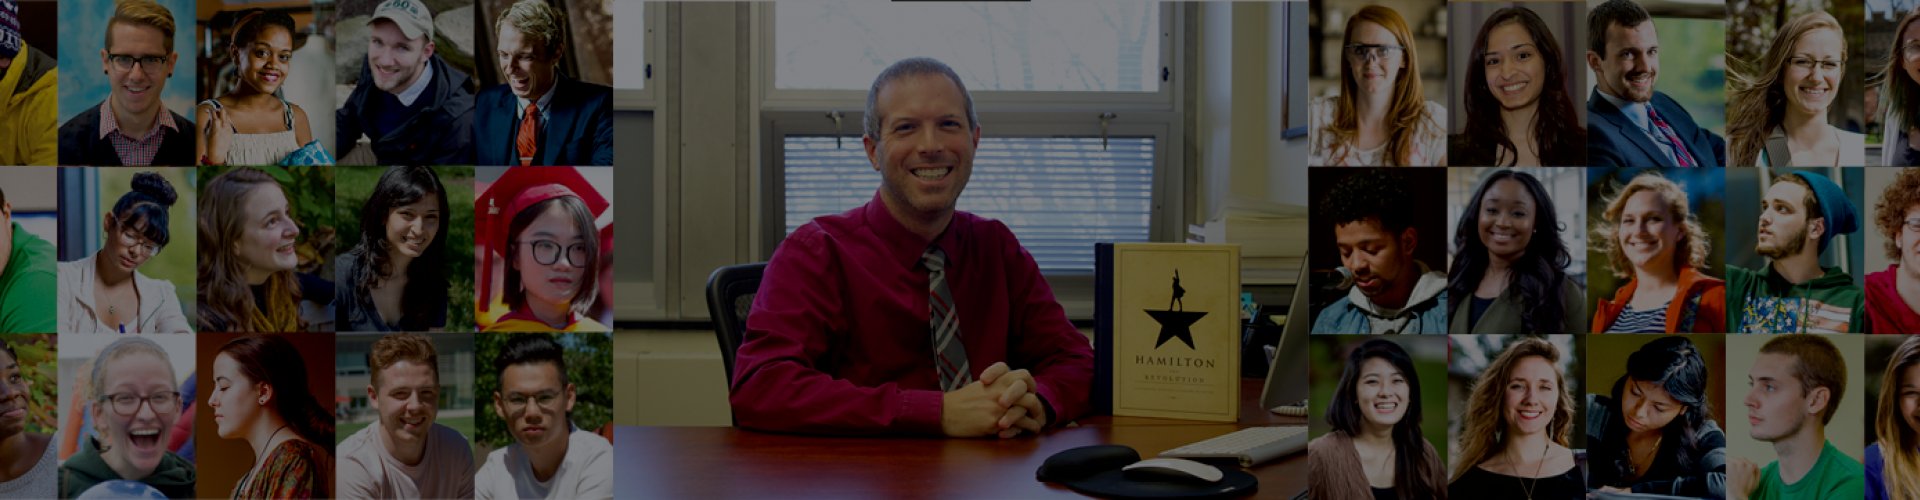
[474,333,612,500]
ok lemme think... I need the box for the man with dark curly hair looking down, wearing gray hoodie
[1313,169,1448,335]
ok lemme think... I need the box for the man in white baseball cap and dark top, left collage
[334,0,474,165]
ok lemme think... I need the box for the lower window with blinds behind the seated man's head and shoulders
[781,135,1156,273]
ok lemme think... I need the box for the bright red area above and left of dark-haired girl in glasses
[474,167,609,312]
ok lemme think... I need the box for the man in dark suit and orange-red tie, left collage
[474,0,612,165]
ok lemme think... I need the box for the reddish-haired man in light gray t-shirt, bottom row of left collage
[334,333,474,498]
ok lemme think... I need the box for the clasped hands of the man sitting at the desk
[941,362,1046,438]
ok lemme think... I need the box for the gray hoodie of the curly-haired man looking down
[1313,263,1446,335]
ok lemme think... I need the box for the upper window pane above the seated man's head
[774,0,1162,92]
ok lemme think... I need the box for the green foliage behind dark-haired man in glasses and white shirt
[474,333,612,448]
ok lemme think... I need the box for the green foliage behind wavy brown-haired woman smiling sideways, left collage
[200,165,340,281]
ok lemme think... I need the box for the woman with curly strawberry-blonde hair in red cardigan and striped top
[1592,171,1726,333]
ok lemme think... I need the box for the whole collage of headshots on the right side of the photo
[1306,0,1920,500]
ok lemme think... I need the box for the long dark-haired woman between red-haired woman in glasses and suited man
[1448,8,1586,167]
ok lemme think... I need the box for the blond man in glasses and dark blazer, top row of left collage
[60,0,194,165]
